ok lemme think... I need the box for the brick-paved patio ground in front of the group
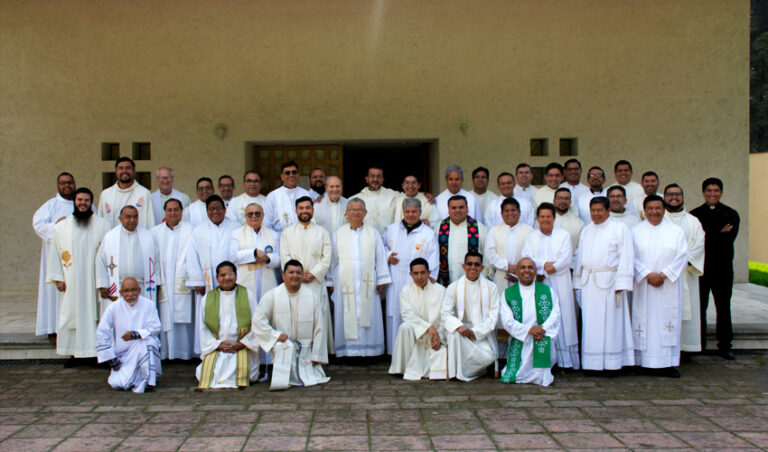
[0,353,768,452]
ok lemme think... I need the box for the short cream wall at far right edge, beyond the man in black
[749,152,768,263]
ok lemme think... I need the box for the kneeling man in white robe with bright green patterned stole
[499,257,560,386]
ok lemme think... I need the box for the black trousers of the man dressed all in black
[699,269,733,352]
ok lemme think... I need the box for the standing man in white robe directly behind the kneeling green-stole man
[523,202,579,369]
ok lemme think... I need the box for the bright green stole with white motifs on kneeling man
[501,281,552,383]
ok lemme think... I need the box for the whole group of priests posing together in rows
[33,157,739,391]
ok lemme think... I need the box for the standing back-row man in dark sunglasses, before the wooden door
[264,160,309,234]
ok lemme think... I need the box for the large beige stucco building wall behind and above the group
[0,0,749,285]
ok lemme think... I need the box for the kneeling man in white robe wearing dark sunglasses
[440,251,500,381]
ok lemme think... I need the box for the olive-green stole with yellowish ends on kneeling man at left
[197,284,251,390]
